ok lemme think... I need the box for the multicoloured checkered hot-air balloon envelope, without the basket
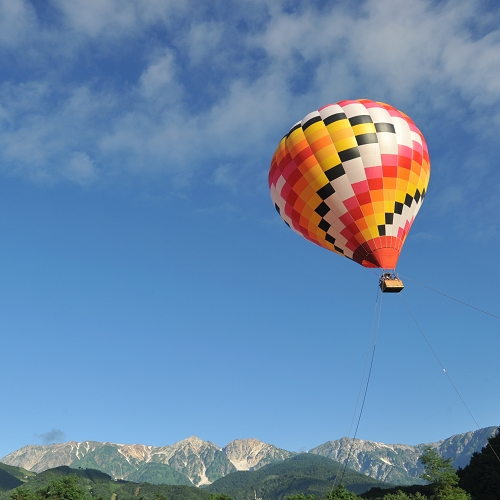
[269,99,430,269]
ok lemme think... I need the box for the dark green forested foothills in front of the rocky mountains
[0,453,387,500]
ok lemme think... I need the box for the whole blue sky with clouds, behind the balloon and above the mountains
[0,0,500,456]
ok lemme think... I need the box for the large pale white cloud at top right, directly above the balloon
[255,0,500,110]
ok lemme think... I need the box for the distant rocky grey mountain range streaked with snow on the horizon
[0,427,497,486]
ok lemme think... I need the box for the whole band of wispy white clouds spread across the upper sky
[0,0,500,234]
